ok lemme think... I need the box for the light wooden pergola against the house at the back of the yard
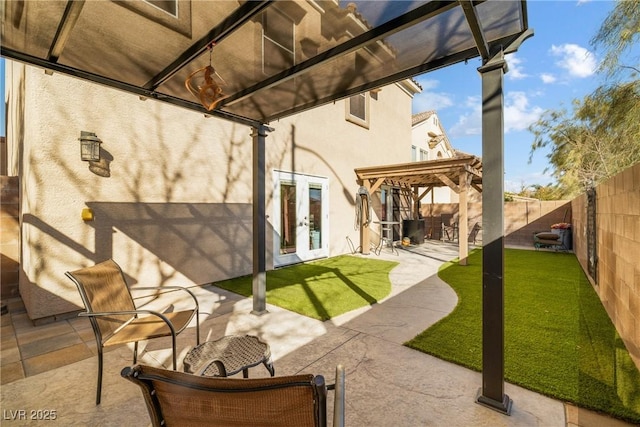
[355,155,482,265]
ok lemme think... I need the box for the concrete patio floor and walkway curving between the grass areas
[0,242,629,427]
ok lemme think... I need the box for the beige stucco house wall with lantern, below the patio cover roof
[7,61,412,319]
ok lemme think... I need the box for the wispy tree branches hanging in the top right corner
[591,0,640,77]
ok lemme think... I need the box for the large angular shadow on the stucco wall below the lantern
[87,202,253,284]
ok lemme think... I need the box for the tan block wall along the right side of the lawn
[572,163,640,369]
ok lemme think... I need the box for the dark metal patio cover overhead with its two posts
[0,0,533,413]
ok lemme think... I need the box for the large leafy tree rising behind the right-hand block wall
[529,80,640,196]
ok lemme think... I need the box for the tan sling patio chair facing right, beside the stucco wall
[65,260,200,405]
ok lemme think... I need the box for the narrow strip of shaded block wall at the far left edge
[0,176,20,302]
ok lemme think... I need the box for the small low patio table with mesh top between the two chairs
[183,335,275,378]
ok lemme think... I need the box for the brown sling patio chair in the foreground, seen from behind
[121,365,345,427]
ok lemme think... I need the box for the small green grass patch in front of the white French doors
[215,255,398,320]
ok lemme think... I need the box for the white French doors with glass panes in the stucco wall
[273,171,329,267]
